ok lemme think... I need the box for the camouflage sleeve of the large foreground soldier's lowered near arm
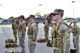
[61,26,72,50]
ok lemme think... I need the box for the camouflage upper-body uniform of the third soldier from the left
[27,23,38,38]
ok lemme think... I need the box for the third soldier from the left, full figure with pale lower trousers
[27,15,38,53]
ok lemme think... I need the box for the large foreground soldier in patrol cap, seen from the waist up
[52,9,71,53]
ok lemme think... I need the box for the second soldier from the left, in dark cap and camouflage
[18,15,26,53]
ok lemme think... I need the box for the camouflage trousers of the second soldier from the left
[18,31,25,53]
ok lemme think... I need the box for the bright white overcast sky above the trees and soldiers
[0,0,80,18]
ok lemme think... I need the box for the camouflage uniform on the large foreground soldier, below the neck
[52,22,71,53]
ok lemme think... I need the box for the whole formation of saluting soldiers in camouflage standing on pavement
[12,9,80,53]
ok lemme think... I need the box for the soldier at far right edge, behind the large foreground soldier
[70,20,80,53]
